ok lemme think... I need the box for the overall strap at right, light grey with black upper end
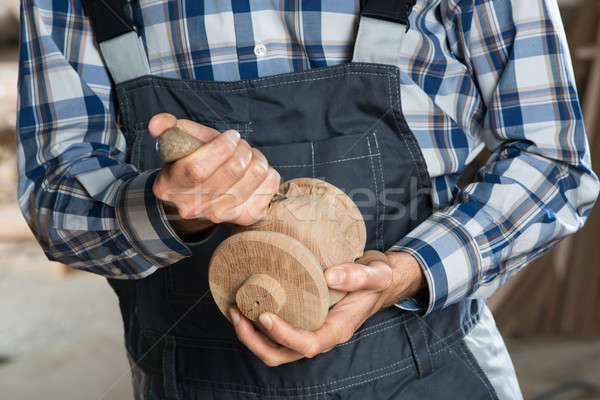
[352,0,416,66]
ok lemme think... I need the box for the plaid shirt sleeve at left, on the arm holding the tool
[17,0,191,279]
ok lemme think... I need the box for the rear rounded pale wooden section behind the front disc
[239,178,367,305]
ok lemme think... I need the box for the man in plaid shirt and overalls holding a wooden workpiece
[19,0,598,399]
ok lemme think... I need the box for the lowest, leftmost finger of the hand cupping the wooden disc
[229,307,303,367]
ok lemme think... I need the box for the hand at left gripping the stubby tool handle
[148,114,280,237]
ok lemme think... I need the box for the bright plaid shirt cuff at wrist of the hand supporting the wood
[390,213,481,315]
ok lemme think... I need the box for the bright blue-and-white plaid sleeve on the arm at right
[392,0,598,314]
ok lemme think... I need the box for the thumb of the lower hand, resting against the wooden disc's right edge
[325,261,393,292]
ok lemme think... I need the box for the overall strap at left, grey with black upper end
[82,0,150,84]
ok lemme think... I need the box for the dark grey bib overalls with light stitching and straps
[87,0,510,400]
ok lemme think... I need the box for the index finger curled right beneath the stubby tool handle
[171,130,240,186]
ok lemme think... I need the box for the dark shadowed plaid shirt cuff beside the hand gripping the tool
[116,170,192,268]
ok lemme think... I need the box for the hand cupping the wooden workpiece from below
[230,251,425,366]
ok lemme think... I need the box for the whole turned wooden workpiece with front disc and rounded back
[209,178,366,330]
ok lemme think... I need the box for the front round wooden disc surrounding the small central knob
[208,231,330,330]
